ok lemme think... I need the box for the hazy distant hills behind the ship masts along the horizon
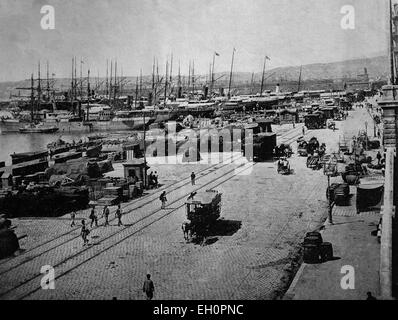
[0,56,388,100]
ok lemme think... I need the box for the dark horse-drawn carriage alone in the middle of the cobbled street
[182,190,221,243]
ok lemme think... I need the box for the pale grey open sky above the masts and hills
[0,0,388,81]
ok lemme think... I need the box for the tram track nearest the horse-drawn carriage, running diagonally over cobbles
[0,159,256,299]
